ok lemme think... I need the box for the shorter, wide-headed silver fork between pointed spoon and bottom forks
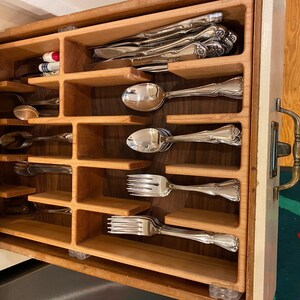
[127,174,240,202]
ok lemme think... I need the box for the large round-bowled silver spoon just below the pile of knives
[122,76,243,111]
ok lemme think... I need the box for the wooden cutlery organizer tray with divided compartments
[0,0,253,292]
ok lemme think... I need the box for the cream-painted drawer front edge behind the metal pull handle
[253,0,285,300]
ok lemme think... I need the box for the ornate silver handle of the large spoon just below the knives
[165,76,243,99]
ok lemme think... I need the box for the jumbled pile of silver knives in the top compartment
[94,12,238,72]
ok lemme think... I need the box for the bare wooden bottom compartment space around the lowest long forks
[76,211,237,285]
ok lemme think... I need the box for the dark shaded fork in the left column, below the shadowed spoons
[14,161,72,176]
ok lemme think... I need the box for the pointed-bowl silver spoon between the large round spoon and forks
[126,124,241,153]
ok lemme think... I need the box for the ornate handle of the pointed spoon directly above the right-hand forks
[165,125,241,146]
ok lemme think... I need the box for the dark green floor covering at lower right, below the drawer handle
[276,172,300,300]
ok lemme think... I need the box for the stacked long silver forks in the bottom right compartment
[107,216,238,252]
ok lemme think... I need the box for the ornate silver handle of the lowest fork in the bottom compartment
[159,226,239,252]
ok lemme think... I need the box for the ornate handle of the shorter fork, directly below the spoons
[170,179,240,202]
